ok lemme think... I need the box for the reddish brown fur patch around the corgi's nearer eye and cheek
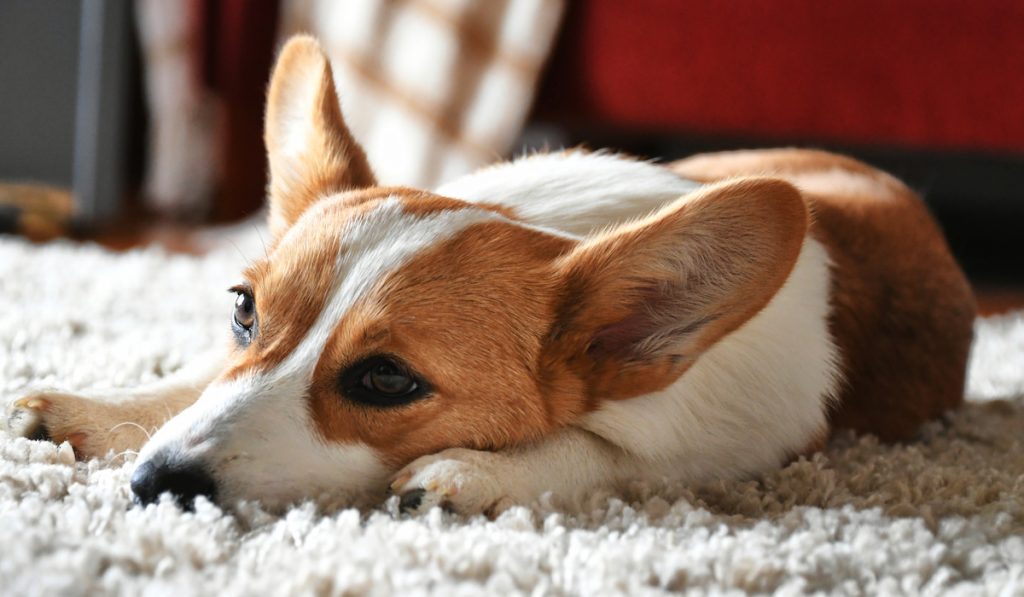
[310,218,580,466]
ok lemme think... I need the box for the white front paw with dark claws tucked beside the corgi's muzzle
[391,447,514,516]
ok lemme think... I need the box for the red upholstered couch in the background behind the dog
[536,0,1024,156]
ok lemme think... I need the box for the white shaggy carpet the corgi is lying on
[0,239,1024,596]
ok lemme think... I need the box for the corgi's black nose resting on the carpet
[131,455,217,510]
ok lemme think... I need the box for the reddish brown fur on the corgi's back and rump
[672,150,976,440]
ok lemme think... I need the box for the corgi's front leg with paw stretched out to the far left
[7,351,224,459]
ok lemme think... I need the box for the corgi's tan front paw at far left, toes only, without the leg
[7,392,144,460]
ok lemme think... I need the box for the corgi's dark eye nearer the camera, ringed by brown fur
[341,356,428,407]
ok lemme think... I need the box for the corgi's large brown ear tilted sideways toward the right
[548,178,808,399]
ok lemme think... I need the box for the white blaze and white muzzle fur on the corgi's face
[139,198,502,499]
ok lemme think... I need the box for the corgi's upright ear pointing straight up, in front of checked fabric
[263,36,376,238]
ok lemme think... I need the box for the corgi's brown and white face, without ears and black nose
[144,188,572,503]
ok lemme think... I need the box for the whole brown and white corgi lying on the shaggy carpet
[11,37,975,514]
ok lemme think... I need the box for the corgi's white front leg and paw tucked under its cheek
[391,427,644,515]
